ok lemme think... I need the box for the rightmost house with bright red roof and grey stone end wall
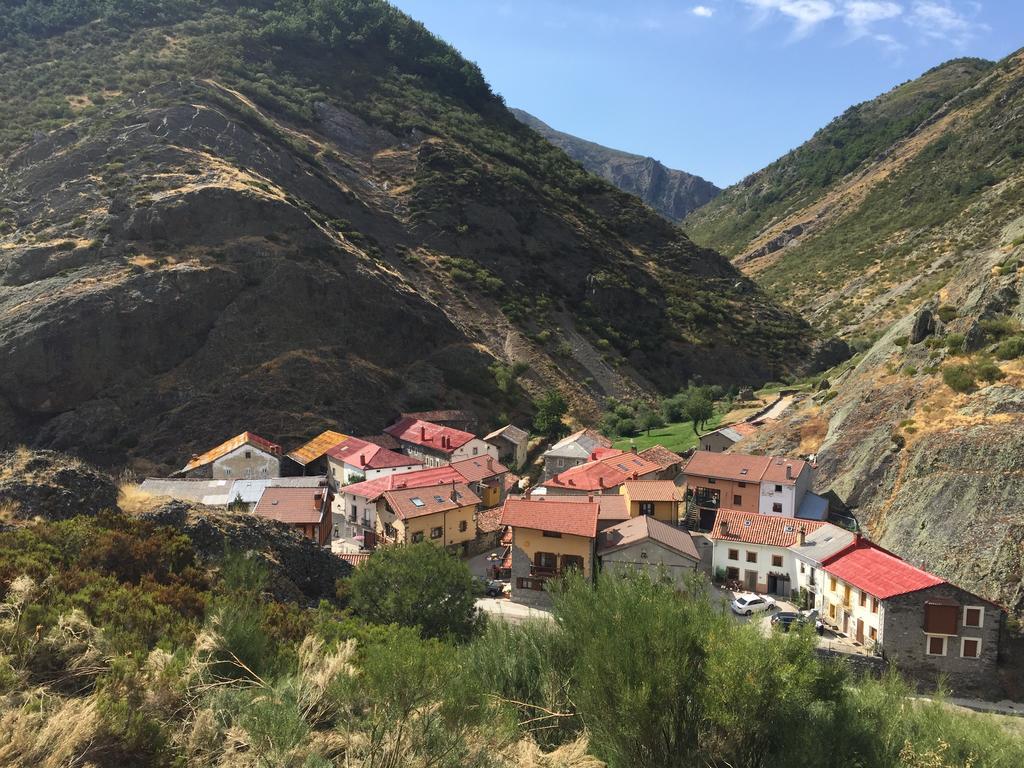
[822,539,1006,693]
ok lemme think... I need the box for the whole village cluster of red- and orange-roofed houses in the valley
[139,411,1008,698]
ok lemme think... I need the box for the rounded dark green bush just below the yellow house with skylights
[349,542,481,640]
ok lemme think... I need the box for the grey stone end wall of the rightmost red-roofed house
[880,584,1005,696]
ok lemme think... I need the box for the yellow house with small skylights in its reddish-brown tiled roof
[376,482,480,554]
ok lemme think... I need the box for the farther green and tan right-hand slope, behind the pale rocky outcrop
[685,52,1024,337]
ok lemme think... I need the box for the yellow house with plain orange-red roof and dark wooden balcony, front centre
[502,497,598,604]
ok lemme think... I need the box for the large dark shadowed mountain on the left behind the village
[0,0,836,471]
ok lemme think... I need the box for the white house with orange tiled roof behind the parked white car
[710,510,825,599]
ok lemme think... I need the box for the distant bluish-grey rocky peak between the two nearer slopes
[512,110,722,222]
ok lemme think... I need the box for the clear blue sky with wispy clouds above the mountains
[392,0,1024,185]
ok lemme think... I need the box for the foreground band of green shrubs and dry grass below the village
[0,455,1024,768]
